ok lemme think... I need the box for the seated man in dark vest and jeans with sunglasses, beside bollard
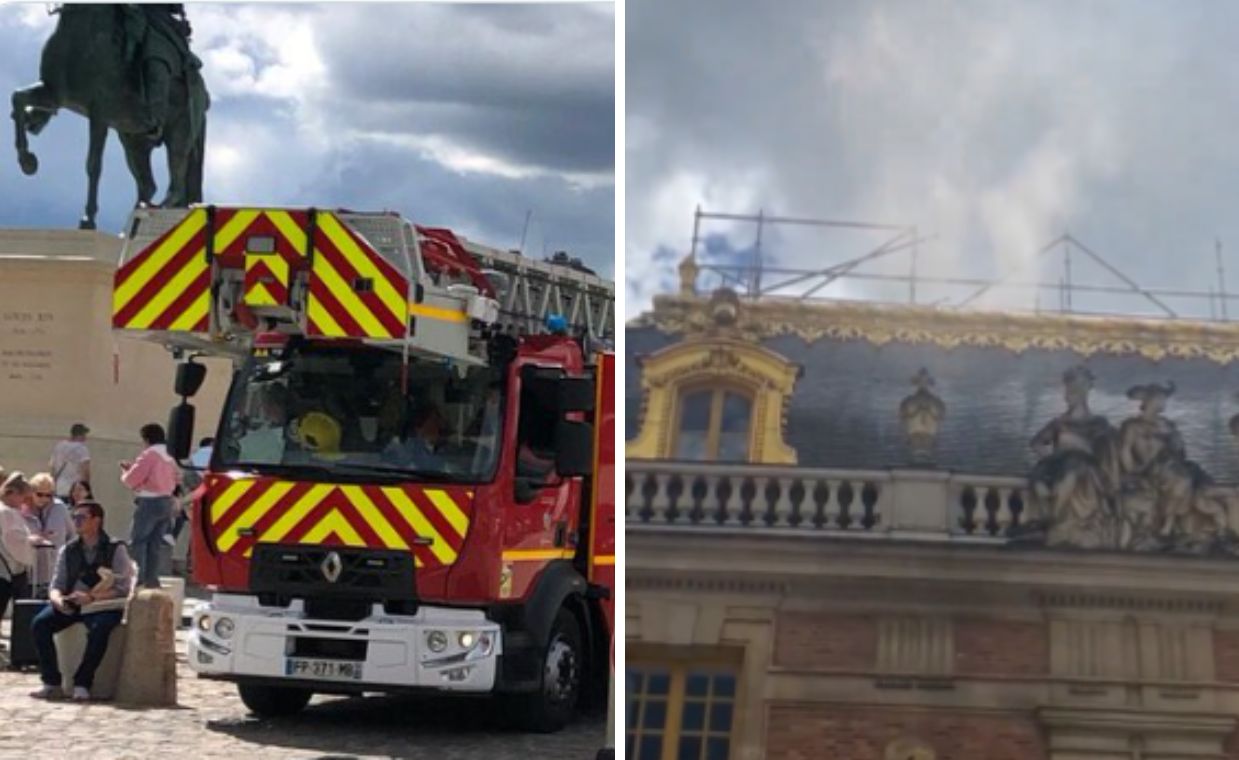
[31,501,134,700]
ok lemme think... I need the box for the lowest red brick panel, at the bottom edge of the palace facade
[766,704,1048,760]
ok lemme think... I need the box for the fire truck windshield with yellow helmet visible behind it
[216,347,503,482]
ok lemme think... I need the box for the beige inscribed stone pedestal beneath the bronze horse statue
[0,229,232,538]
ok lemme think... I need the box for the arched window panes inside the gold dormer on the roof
[672,387,753,461]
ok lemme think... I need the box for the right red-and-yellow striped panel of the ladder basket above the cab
[306,212,409,338]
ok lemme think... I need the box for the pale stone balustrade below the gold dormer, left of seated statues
[624,460,1033,541]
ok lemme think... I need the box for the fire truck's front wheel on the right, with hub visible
[514,610,585,734]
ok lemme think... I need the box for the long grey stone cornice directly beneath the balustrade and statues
[626,533,1239,616]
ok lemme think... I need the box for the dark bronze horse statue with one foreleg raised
[12,4,209,229]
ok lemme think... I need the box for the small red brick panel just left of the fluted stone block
[774,612,877,671]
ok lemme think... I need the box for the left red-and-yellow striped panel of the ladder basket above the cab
[112,208,211,332]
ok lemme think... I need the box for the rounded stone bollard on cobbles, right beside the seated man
[116,589,176,707]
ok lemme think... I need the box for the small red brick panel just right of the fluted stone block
[955,617,1049,676]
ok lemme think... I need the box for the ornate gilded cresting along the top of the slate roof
[628,295,1239,363]
